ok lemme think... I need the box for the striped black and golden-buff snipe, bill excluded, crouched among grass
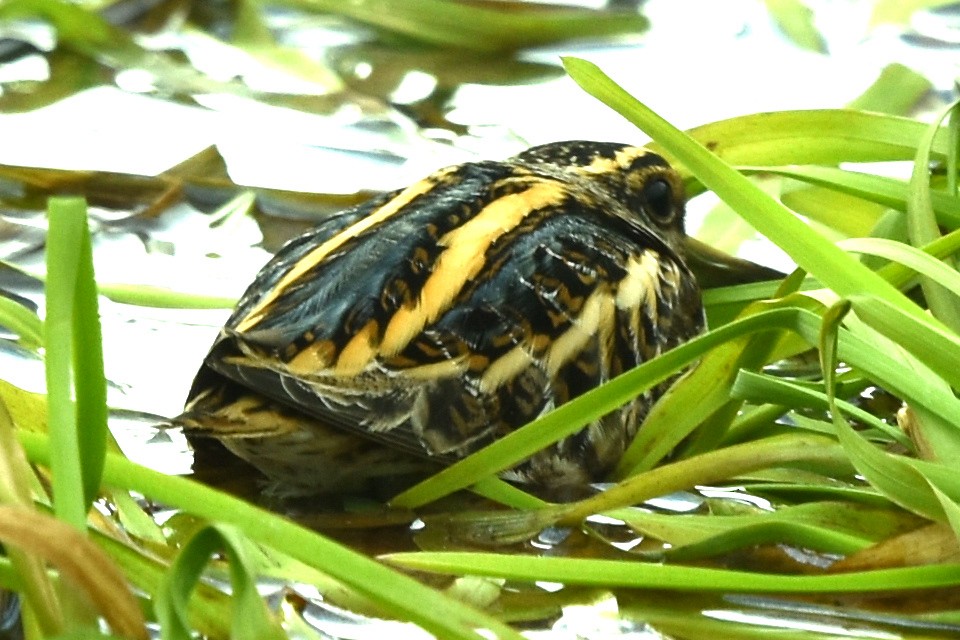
[178,142,703,492]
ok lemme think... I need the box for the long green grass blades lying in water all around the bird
[0,0,960,640]
